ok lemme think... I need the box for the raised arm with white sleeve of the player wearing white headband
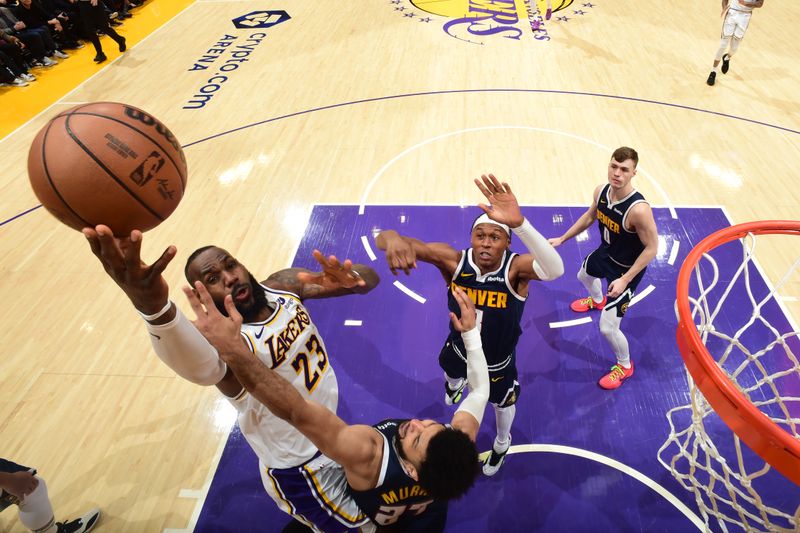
[475,174,564,281]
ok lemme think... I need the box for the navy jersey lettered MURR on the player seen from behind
[350,420,433,527]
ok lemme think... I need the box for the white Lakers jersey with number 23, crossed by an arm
[230,285,339,468]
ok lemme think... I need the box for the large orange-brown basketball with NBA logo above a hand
[28,102,186,236]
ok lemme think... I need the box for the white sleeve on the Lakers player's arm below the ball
[146,306,227,385]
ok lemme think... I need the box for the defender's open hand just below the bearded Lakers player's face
[183,281,244,360]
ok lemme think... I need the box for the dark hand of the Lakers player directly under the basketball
[83,224,177,314]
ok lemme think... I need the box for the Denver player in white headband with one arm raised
[375,174,564,476]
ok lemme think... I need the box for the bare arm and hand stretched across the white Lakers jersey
[183,281,383,486]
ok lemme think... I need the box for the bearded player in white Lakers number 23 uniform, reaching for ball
[83,226,379,532]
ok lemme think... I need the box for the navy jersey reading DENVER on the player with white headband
[447,248,525,368]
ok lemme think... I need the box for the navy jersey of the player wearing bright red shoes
[597,185,646,267]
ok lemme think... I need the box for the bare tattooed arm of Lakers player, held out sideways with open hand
[264,250,380,300]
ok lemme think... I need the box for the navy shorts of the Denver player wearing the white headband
[439,339,520,407]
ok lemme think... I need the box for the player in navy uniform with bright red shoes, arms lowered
[550,146,658,390]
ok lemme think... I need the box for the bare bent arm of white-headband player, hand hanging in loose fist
[375,229,461,279]
